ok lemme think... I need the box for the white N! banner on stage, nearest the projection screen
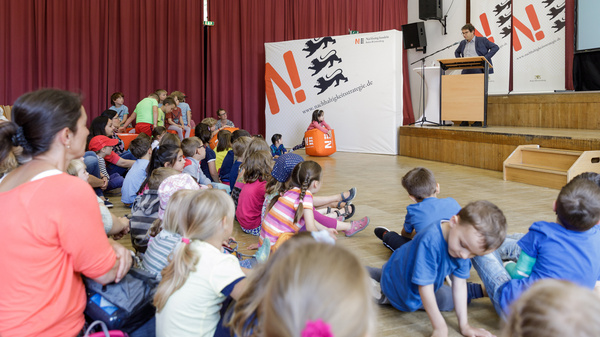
[512,1,565,92]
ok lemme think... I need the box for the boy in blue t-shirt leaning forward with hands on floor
[370,201,506,336]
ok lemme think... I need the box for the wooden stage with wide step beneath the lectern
[398,92,600,171]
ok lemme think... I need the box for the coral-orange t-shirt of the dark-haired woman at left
[0,173,116,337]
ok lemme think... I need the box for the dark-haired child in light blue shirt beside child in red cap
[121,133,152,207]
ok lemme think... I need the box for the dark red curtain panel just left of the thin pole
[106,0,204,122]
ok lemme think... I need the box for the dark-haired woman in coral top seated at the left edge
[0,89,132,337]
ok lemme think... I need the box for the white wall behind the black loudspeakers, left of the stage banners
[404,0,466,120]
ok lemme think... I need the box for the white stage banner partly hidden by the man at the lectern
[471,0,512,95]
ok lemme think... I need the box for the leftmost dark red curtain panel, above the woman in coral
[0,0,108,116]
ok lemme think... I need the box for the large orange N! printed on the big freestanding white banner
[265,50,306,115]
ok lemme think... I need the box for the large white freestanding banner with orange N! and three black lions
[265,30,402,155]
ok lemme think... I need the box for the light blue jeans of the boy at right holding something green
[471,251,508,319]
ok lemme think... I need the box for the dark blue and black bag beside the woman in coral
[83,268,158,333]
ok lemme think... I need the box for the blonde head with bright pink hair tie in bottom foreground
[260,242,376,337]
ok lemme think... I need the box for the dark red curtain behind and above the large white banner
[206,0,414,134]
